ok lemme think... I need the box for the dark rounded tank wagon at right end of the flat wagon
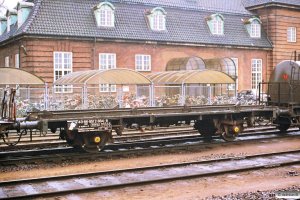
[259,60,300,131]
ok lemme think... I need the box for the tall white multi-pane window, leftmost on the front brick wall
[53,52,73,93]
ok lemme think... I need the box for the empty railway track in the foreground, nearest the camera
[0,150,300,199]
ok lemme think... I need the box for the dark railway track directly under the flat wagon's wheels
[0,129,300,166]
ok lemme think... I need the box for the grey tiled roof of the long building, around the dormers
[0,0,272,48]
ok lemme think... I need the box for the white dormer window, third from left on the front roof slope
[207,14,224,35]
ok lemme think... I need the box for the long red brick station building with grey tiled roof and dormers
[0,0,300,94]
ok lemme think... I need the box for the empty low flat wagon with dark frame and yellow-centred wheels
[26,105,274,151]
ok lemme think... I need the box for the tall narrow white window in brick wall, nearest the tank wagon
[251,59,262,91]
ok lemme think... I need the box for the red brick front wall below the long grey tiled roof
[0,39,270,90]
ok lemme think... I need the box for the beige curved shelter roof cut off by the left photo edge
[0,67,45,85]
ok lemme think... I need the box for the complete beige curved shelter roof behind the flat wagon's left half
[54,68,151,85]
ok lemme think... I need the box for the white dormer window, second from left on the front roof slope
[147,7,167,31]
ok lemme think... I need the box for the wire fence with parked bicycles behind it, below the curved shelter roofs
[0,85,241,117]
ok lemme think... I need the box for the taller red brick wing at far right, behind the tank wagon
[244,0,300,76]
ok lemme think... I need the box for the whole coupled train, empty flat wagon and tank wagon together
[0,61,300,152]
